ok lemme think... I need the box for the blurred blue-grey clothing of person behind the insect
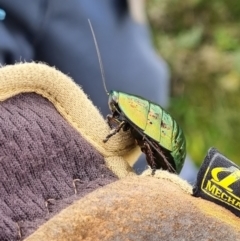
[0,0,196,180]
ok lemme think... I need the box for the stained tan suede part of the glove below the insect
[26,174,240,241]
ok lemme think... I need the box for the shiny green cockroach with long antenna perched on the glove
[88,20,186,174]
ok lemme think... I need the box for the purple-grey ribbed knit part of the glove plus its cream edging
[0,63,139,240]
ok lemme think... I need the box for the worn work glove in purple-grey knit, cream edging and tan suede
[0,63,240,241]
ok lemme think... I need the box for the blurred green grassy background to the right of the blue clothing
[146,0,240,166]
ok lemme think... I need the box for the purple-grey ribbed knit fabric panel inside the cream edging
[0,93,117,241]
